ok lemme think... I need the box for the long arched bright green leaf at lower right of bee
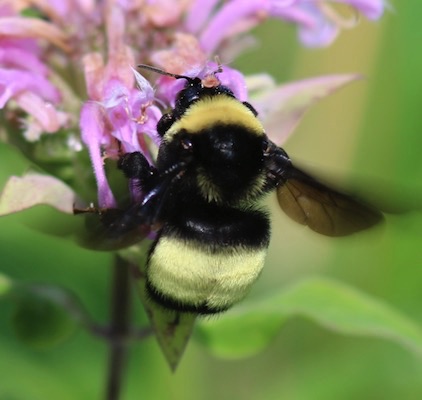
[196,278,422,358]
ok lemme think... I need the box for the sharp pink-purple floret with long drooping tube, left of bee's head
[80,7,161,207]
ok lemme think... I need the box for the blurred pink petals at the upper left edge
[0,6,67,141]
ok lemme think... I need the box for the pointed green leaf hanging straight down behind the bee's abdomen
[119,245,196,371]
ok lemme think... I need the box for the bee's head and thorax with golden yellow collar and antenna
[138,67,266,203]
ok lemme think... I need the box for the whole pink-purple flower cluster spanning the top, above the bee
[0,0,385,207]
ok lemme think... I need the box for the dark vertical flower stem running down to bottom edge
[106,256,130,400]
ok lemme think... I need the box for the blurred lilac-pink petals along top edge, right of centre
[185,0,385,50]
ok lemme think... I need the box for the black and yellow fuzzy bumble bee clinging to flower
[118,66,382,314]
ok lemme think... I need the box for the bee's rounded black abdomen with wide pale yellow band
[147,211,269,314]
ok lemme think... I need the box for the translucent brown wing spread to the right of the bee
[277,165,383,236]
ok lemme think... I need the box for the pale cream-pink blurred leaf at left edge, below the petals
[0,173,76,216]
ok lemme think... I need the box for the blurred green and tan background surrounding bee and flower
[0,1,422,400]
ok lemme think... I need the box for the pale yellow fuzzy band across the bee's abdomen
[148,237,266,311]
